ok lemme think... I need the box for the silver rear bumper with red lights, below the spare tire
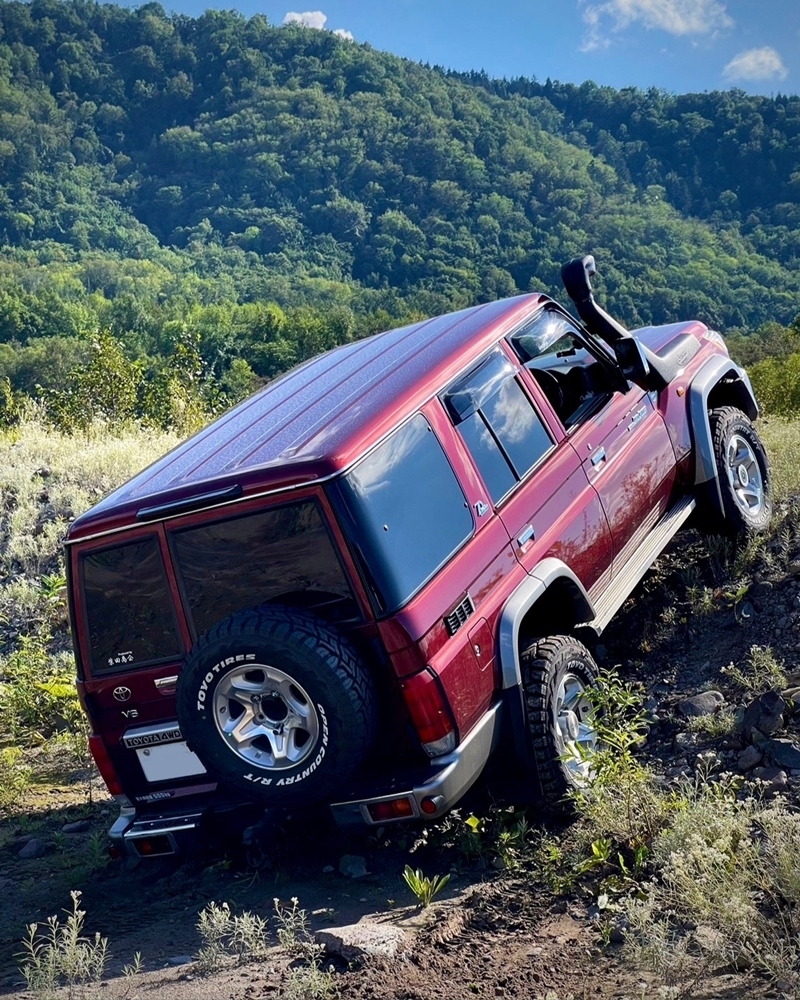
[109,702,502,857]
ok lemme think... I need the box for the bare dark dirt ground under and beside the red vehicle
[0,533,800,1000]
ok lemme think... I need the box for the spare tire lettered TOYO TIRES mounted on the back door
[177,605,376,804]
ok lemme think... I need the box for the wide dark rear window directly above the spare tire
[170,500,358,634]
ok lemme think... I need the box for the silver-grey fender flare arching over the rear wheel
[498,557,595,691]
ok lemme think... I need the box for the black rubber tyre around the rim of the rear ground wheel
[520,635,598,814]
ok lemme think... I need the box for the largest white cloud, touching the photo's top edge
[578,0,733,52]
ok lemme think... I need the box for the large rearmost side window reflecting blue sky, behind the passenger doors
[332,414,473,611]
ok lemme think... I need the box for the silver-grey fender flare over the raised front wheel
[689,355,758,516]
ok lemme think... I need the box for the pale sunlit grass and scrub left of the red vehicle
[0,421,178,813]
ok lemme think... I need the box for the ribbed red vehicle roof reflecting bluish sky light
[68,294,549,541]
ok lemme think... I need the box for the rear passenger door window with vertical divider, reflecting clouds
[444,354,553,503]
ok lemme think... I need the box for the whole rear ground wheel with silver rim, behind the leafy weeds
[520,635,598,812]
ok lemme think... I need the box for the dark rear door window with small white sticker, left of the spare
[81,535,183,673]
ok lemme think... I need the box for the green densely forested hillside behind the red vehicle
[0,0,800,333]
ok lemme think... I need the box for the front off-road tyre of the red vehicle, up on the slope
[700,406,772,539]
